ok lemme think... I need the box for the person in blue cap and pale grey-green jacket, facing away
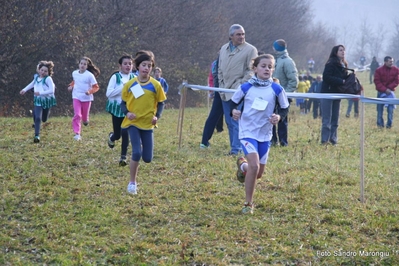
[272,39,298,146]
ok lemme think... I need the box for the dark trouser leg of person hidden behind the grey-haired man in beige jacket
[201,92,223,146]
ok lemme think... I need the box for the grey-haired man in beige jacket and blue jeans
[218,24,258,155]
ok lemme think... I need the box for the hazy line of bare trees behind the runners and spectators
[0,0,346,116]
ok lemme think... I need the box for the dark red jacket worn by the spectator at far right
[374,65,399,92]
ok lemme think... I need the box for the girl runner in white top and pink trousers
[68,57,100,140]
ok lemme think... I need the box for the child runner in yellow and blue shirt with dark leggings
[121,53,166,194]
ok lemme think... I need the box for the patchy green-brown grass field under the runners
[0,73,399,265]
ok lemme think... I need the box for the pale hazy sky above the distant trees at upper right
[312,0,399,60]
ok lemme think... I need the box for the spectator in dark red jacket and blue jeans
[374,56,399,128]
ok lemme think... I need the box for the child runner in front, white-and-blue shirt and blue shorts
[231,54,289,214]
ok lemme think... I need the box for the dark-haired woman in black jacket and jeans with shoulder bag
[321,45,348,145]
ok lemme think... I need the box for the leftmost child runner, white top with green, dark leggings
[19,61,56,143]
